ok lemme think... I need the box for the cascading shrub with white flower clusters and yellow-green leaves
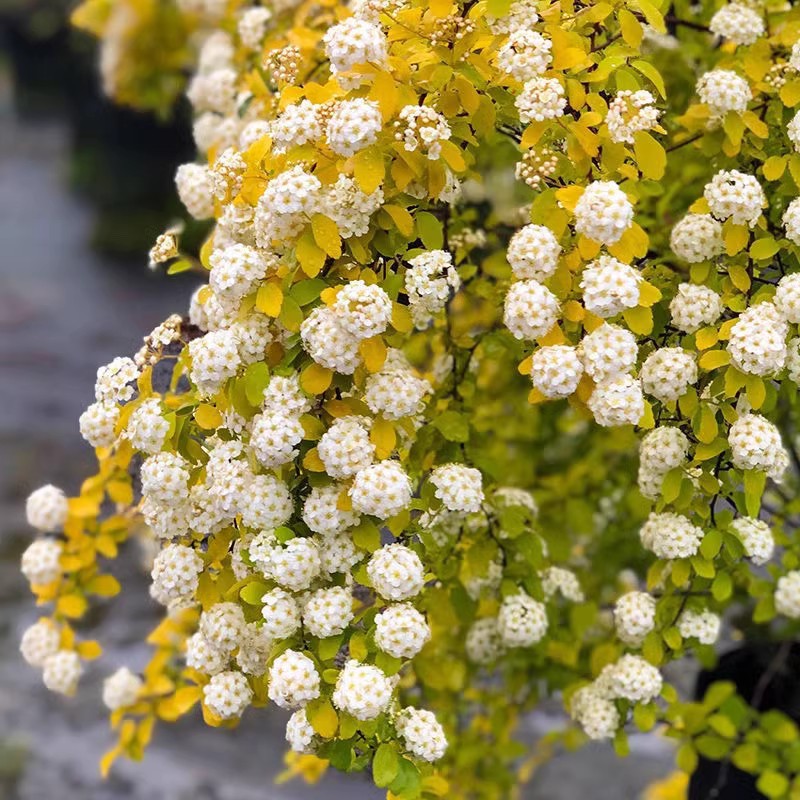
[22,0,800,799]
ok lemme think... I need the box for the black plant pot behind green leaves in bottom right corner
[689,642,800,800]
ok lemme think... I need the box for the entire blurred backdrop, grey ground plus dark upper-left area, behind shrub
[0,0,672,800]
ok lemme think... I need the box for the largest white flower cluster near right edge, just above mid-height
[727,302,789,375]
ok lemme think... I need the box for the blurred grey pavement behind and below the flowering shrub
[0,76,671,800]
